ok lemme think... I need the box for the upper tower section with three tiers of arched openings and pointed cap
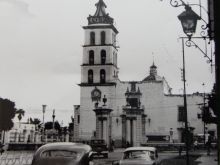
[81,0,118,86]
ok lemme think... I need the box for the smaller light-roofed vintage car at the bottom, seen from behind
[113,147,160,165]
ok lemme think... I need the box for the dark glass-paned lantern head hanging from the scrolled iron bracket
[178,5,201,40]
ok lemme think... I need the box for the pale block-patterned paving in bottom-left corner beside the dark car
[0,151,33,165]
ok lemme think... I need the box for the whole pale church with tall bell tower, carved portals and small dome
[74,0,215,146]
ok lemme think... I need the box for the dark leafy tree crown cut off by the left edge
[0,98,16,131]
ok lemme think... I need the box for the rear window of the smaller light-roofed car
[123,150,154,160]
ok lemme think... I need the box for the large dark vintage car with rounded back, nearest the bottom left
[31,142,93,165]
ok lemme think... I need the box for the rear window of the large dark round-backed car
[41,150,82,159]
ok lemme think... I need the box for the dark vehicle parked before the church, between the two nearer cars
[90,139,109,158]
